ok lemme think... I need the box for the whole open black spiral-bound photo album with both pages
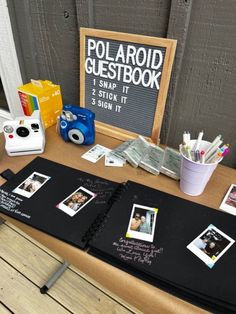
[0,157,236,313]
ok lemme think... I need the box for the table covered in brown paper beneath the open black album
[0,127,236,313]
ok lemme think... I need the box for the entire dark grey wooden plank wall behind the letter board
[8,0,236,167]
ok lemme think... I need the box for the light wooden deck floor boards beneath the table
[0,222,138,314]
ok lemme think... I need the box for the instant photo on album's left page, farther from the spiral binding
[12,172,51,198]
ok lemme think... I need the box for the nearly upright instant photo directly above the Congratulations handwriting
[126,204,158,242]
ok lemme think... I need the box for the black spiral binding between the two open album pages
[82,183,128,243]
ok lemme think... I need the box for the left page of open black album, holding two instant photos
[0,157,119,248]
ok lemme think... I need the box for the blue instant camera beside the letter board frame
[60,105,95,145]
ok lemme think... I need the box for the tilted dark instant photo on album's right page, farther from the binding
[187,224,235,268]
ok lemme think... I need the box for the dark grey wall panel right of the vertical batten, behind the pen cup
[167,0,236,168]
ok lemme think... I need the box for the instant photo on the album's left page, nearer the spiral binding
[56,186,96,217]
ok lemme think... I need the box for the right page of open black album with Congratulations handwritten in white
[89,181,236,312]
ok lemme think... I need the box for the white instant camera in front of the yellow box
[3,110,45,156]
